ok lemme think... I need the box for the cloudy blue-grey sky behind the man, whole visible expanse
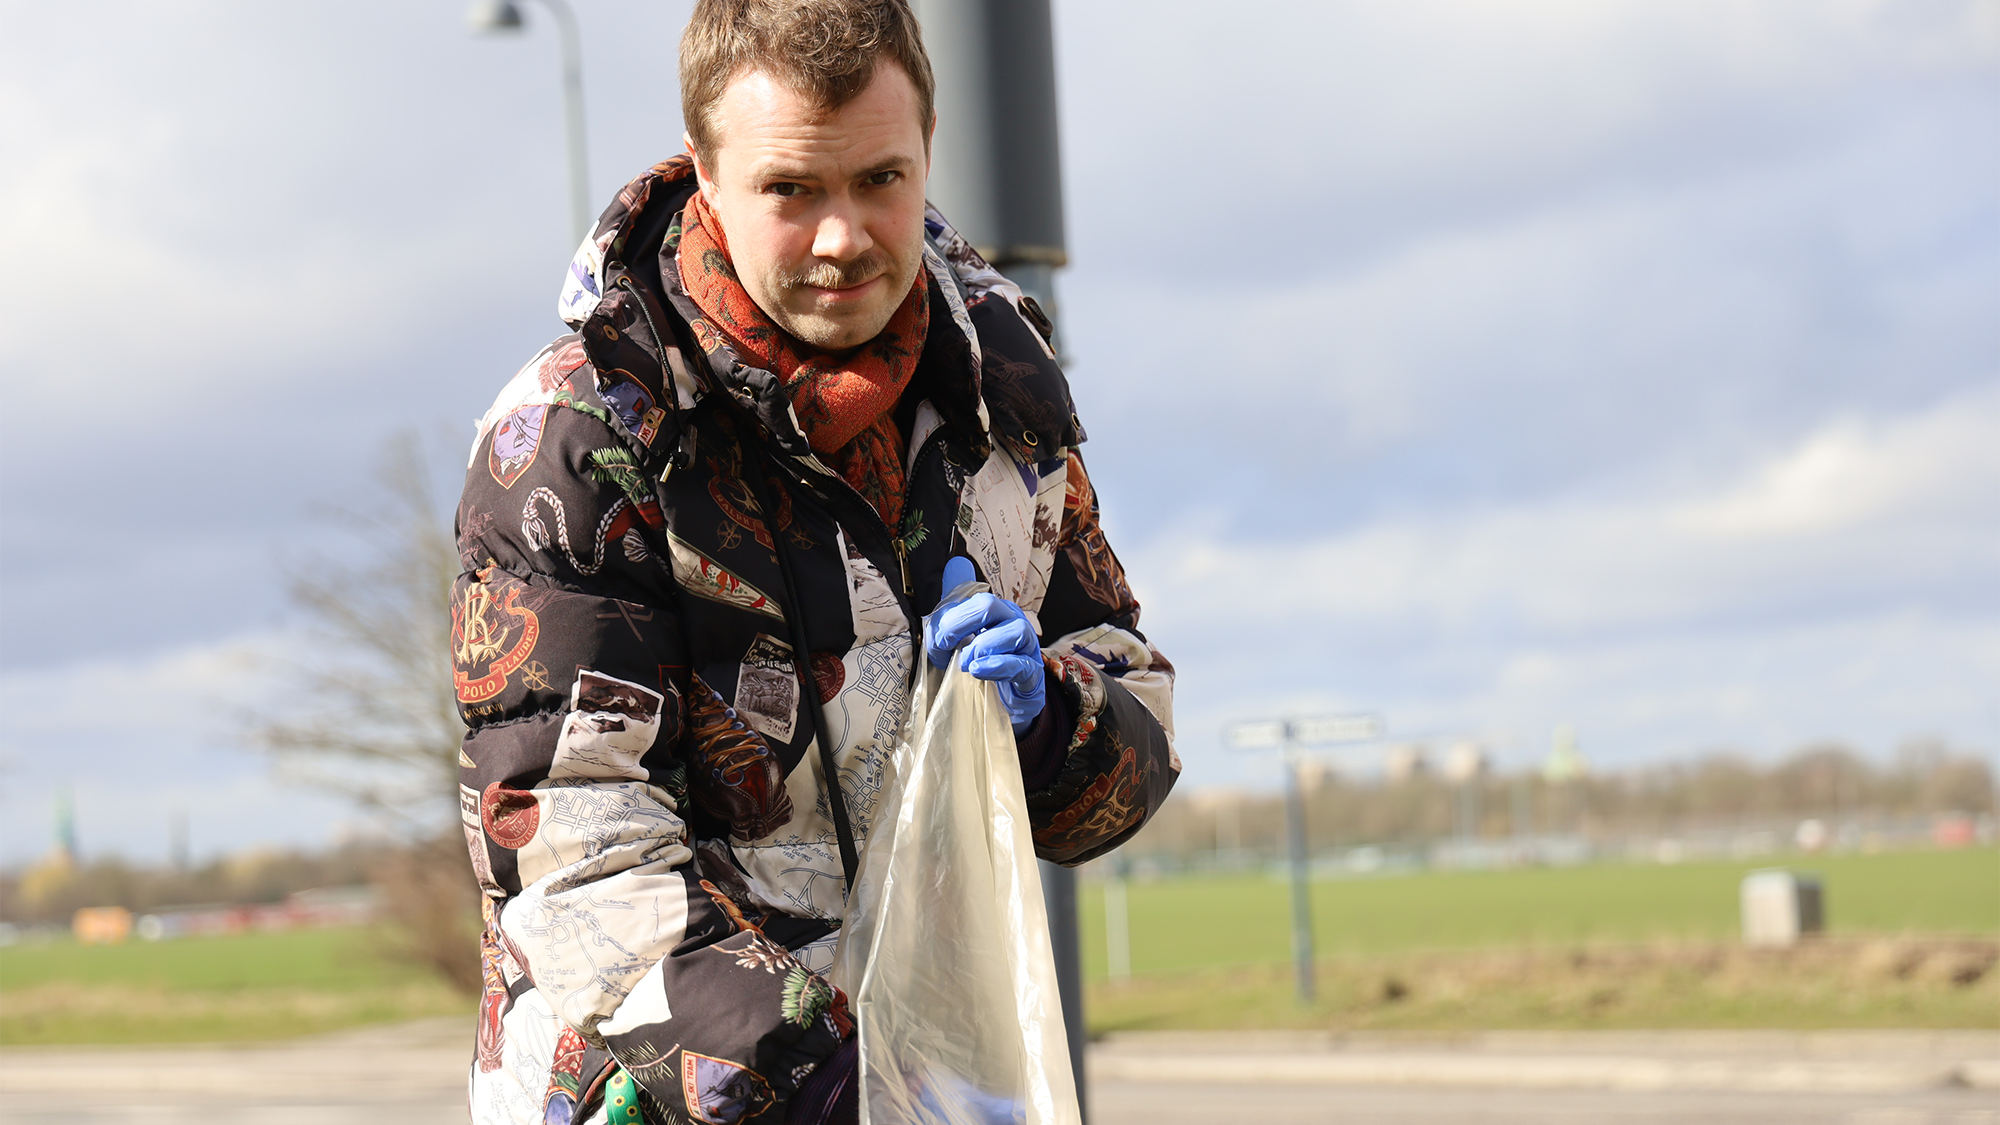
[0,0,2000,863]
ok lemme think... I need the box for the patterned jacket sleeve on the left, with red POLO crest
[452,376,852,1123]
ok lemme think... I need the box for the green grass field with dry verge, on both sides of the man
[0,849,2000,1043]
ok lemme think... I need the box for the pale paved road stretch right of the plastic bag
[1090,1031,2000,1125]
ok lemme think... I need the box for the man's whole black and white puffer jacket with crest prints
[452,158,1180,1125]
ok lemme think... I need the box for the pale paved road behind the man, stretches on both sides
[0,1019,2000,1125]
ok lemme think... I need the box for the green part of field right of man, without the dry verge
[1080,849,2000,981]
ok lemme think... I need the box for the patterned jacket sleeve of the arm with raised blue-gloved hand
[1028,450,1180,865]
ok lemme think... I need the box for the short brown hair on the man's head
[680,0,938,162]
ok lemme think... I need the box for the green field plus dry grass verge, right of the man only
[1080,849,2000,1033]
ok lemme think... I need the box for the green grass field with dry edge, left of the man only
[0,929,472,1043]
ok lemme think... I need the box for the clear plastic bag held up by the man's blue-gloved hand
[834,585,1082,1125]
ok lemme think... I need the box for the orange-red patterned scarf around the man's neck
[674,192,930,534]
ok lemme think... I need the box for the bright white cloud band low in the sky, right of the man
[1146,386,2000,633]
